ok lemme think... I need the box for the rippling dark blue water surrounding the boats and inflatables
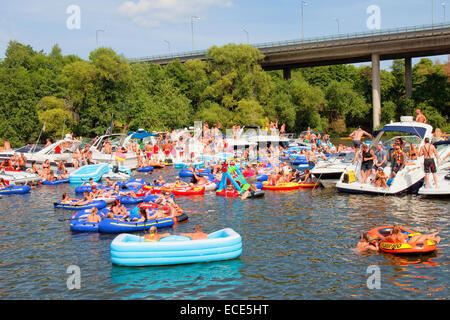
[0,168,450,300]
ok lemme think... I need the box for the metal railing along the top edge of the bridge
[128,23,450,62]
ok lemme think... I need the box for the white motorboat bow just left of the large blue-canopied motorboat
[310,151,355,187]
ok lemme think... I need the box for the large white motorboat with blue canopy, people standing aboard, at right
[336,117,433,195]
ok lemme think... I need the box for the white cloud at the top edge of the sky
[117,0,232,27]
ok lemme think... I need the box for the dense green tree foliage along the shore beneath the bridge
[0,41,450,146]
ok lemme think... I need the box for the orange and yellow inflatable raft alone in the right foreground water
[368,226,437,254]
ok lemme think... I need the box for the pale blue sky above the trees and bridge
[0,0,450,69]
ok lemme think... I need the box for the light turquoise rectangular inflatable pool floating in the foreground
[111,228,242,266]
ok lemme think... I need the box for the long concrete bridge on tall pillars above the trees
[129,23,450,128]
